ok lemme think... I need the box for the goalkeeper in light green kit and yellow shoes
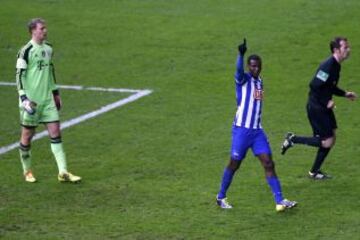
[16,18,81,183]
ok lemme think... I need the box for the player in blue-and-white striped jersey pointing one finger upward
[216,39,297,212]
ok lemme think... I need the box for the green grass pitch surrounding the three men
[0,0,360,240]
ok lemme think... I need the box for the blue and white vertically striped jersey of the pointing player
[233,55,263,129]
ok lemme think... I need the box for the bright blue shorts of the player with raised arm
[231,126,271,161]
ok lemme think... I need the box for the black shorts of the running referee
[306,104,337,139]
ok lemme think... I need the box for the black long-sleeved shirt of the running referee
[308,56,345,108]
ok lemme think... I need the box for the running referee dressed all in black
[281,37,357,180]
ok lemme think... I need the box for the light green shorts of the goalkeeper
[20,101,60,127]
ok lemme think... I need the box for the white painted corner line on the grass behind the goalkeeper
[0,82,152,155]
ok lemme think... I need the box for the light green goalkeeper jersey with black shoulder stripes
[16,40,57,104]
